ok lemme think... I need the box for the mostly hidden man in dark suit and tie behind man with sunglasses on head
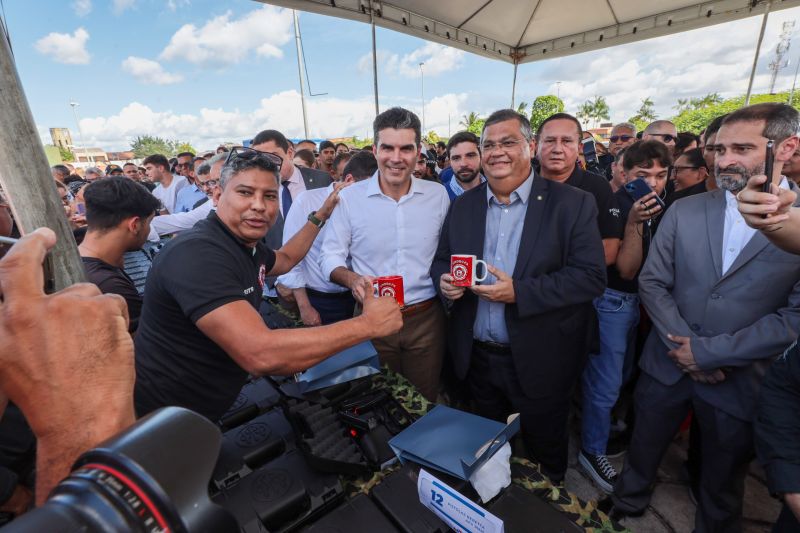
[250,130,331,320]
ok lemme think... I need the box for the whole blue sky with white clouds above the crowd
[5,0,800,150]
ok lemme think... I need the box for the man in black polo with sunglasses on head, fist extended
[135,150,402,420]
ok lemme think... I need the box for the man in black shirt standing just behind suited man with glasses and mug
[536,113,622,265]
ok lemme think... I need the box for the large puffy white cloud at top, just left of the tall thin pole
[159,5,292,65]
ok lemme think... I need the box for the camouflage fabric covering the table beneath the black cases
[342,367,629,533]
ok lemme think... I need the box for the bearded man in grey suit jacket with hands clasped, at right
[600,103,800,533]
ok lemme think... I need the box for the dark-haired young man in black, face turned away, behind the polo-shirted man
[78,177,160,333]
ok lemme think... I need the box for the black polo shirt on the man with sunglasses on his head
[134,211,275,421]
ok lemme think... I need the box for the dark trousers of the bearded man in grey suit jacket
[612,372,754,533]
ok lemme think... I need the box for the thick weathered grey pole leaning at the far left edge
[0,25,86,290]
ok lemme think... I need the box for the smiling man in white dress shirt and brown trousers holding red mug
[320,107,450,400]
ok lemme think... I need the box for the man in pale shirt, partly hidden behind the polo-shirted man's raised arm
[278,152,378,326]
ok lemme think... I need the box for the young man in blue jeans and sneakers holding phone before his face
[578,141,672,493]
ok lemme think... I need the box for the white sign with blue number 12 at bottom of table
[417,469,503,533]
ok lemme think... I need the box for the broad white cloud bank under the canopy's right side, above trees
[520,12,798,122]
